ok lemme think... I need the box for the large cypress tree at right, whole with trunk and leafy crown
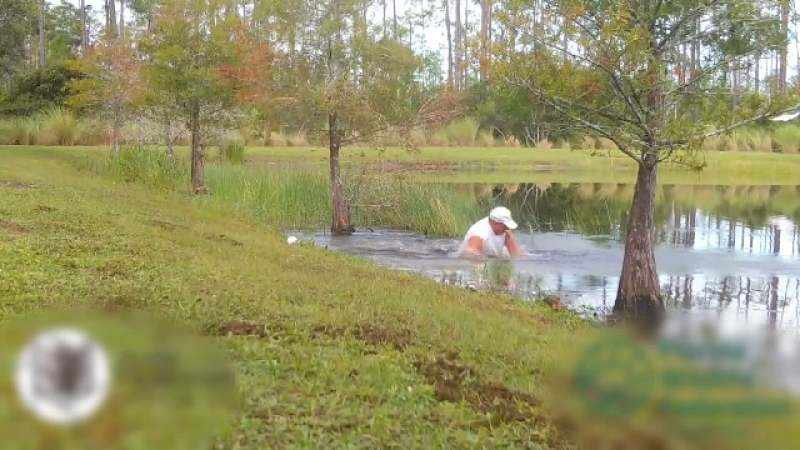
[506,0,792,329]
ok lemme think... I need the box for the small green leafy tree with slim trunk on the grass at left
[141,0,244,194]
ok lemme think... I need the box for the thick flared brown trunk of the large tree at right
[613,162,666,328]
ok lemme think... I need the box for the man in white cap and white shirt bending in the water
[459,206,520,259]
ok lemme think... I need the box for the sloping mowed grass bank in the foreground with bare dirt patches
[0,148,586,449]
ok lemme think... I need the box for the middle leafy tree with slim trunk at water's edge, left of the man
[256,0,456,234]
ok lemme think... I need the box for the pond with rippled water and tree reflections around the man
[289,183,800,334]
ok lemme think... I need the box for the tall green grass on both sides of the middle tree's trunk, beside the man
[206,165,488,237]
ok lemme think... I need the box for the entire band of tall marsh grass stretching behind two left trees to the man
[79,147,489,237]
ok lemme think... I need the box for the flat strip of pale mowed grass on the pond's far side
[29,146,800,185]
